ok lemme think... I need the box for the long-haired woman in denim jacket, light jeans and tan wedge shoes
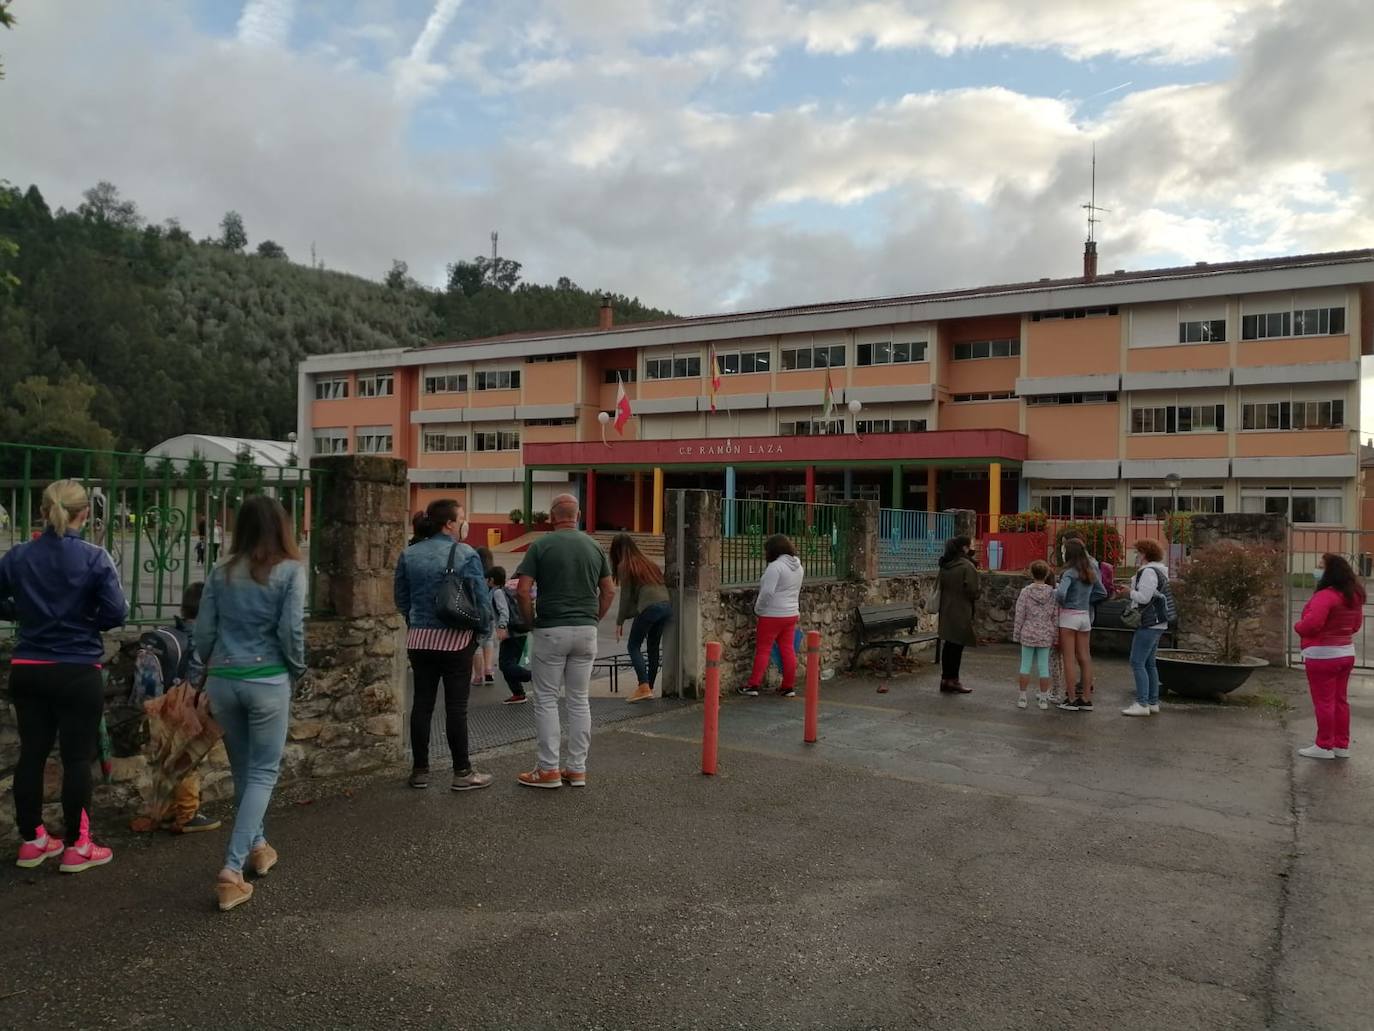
[194,495,305,910]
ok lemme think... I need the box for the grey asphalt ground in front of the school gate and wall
[0,649,1374,1031]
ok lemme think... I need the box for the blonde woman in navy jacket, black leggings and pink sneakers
[0,480,128,873]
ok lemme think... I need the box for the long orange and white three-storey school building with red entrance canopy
[298,250,1374,532]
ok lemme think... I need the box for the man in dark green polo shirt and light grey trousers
[515,494,616,788]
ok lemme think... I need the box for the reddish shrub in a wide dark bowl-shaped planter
[1158,542,1283,698]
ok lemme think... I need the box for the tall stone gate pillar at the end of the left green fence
[300,455,408,778]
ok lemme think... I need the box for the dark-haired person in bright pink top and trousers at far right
[1293,554,1364,759]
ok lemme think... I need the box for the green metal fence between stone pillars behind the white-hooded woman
[720,498,849,587]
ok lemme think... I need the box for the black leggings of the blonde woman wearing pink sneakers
[10,663,104,845]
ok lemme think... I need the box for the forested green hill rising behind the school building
[0,183,671,450]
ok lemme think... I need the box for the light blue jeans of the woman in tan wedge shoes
[205,674,291,873]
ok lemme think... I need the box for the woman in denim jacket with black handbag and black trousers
[396,498,492,792]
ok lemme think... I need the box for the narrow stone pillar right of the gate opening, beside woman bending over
[664,491,720,698]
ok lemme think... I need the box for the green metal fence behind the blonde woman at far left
[0,443,323,635]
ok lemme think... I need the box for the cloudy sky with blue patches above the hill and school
[0,0,1374,313]
